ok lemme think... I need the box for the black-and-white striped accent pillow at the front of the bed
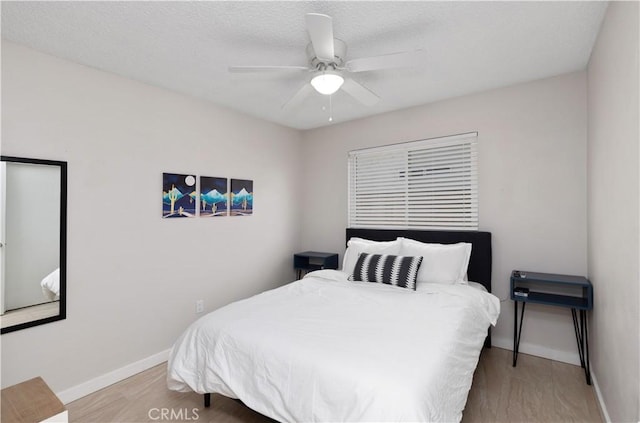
[349,253,422,291]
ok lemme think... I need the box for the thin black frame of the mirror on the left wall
[0,156,67,334]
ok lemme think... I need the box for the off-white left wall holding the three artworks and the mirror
[1,42,301,392]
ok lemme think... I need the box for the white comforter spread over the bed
[167,270,500,422]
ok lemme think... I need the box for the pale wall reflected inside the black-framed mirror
[3,162,60,310]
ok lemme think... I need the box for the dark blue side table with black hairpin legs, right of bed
[510,270,593,385]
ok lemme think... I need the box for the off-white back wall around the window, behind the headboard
[301,72,587,363]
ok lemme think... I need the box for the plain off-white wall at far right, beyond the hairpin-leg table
[587,2,640,422]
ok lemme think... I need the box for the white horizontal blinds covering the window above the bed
[349,132,478,230]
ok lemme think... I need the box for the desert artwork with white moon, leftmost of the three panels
[162,173,198,218]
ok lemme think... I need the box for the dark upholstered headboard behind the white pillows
[347,228,491,292]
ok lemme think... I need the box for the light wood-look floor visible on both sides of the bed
[67,347,602,423]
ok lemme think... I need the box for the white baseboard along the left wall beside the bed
[56,350,170,404]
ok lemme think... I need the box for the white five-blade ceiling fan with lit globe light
[229,13,424,112]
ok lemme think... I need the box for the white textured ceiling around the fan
[2,1,607,129]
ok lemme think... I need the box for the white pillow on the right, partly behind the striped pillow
[400,238,471,284]
